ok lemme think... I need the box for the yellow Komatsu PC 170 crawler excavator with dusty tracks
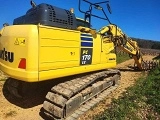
[0,0,156,120]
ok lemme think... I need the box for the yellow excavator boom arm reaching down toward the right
[99,24,143,70]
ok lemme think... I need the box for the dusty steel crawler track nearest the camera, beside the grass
[43,69,120,120]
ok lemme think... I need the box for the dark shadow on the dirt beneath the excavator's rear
[2,77,74,108]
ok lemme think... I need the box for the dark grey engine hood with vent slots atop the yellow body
[13,3,77,29]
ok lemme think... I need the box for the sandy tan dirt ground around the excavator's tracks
[0,56,153,120]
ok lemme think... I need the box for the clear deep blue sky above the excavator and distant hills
[0,0,160,41]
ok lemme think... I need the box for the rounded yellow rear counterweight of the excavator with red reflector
[0,25,39,82]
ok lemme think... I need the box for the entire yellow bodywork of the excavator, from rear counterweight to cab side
[0,25,116,82]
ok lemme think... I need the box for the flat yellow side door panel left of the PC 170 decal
[39,26,79,71]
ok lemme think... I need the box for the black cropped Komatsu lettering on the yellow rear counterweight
[0,48,14,63]
